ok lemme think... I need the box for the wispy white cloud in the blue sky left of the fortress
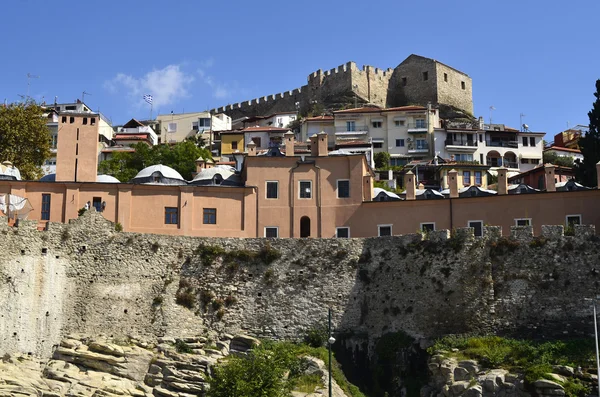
[104,65,194,108]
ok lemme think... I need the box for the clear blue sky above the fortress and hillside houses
[0,0,600,136]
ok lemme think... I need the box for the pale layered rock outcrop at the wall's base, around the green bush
[0,334,345,397]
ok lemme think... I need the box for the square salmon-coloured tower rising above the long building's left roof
[56,115,100,182]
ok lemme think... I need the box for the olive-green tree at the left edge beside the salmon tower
[0,101,51,180]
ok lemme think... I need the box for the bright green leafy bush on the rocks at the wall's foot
[207,347,300,397]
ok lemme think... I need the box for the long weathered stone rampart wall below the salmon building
[0,211,600,356]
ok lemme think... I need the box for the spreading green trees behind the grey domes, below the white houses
[98,140,212,182]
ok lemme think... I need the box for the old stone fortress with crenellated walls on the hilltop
[211,54,473,119]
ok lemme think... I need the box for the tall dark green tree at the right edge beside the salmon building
[575,80,600,186]
